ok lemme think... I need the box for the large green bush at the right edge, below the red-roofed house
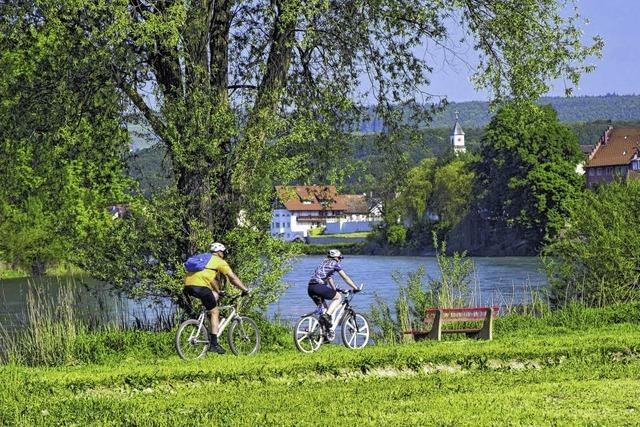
[543,180,640,306]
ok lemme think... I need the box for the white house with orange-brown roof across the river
[271,185,380,241]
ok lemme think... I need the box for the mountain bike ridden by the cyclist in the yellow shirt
[175,292,260,360]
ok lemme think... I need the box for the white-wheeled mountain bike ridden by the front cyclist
[293,286,369,353]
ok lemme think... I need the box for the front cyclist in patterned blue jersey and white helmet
[307,249,360,328]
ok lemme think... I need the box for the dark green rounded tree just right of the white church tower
[477,102,584,249]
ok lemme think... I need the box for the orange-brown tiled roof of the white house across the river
[276,185,347,211]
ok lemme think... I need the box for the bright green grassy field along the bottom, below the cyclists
[0,320,640,426]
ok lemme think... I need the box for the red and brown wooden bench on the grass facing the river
[405,306,500,341]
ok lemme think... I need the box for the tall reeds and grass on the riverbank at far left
[0,278,180,366]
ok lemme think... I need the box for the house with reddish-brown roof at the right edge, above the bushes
[584,126,640,188]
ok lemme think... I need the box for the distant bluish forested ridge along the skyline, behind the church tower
[360,95,640,133]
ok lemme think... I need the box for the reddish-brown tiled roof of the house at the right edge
[586,128,640,167]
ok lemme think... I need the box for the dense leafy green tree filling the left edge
[0,2,129,275]
